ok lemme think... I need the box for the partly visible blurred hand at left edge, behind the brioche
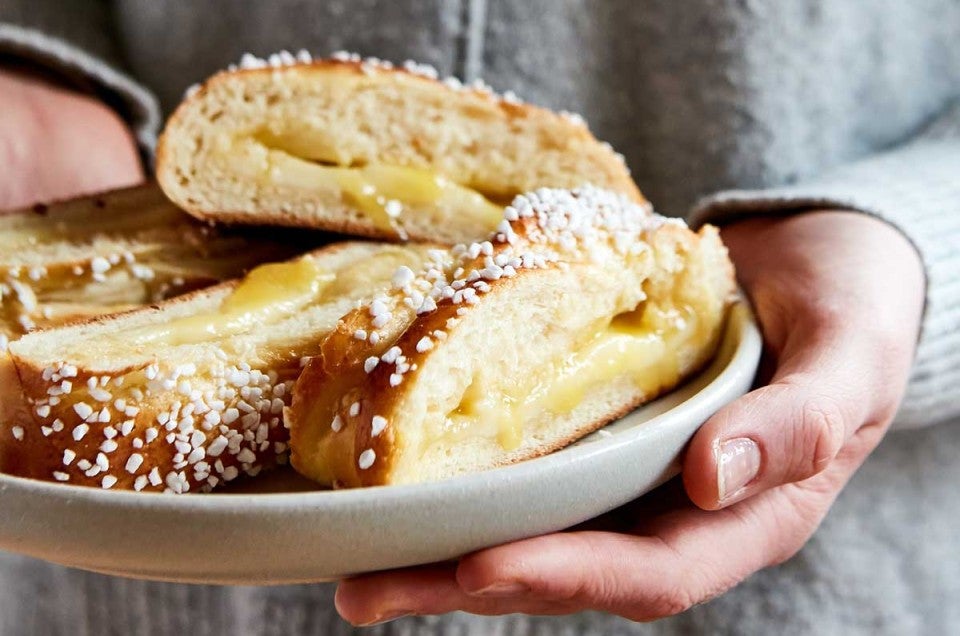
[0,68,143,210]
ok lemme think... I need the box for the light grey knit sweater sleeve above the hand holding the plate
[689,102,960,428]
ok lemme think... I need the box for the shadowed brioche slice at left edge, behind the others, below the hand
[0,184,303,348]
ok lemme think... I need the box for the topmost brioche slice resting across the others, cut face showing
[157,54,643,244]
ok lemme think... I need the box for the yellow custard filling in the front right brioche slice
[440,302,722,451]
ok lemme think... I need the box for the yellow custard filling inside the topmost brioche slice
[219,132,503,236]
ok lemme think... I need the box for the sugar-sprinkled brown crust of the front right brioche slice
[288,187,732,486]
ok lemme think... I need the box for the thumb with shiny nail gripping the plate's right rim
[683,318,893,510]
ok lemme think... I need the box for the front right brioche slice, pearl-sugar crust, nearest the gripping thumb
[287,187,734,487]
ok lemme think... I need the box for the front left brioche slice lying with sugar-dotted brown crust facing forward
[0,243,429,493]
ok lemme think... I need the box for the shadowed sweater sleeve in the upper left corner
[0,0,160,156]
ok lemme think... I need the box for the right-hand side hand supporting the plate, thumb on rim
[336,211,924,624]
